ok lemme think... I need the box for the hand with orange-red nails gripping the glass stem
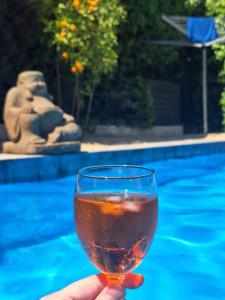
[40,274,144,300]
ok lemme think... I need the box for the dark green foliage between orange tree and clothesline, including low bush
[93,0,188,127]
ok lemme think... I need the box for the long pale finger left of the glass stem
[40,275,105,300]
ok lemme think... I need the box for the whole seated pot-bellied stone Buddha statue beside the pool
[3,71,81,154]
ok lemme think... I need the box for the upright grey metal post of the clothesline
[202,46,208,134]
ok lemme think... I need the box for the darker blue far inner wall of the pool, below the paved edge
[0,142,225,183]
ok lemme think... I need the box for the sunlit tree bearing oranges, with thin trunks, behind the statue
[47,0,126,127]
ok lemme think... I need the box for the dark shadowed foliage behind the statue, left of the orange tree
[0,0,59,122]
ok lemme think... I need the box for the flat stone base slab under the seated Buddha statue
[2,141,80,154]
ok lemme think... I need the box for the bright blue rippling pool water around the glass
[0,154,225,300]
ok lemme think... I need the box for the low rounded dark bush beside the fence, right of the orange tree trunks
[93,76,153,127]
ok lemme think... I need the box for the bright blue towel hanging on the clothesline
[187,17,217,43]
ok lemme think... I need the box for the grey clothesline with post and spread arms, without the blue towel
[148,15,225,134]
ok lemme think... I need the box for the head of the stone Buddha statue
[17,71,48,96]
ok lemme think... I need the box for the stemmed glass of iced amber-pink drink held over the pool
[74,165,158,281]
